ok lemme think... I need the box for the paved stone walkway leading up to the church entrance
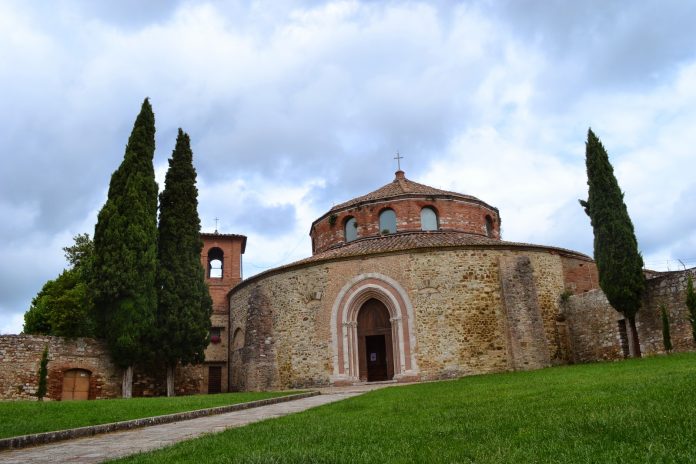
[0,385,388,463]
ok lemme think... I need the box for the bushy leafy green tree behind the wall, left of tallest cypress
[24,234,96,337]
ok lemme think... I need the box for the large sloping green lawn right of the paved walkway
[111,354,696,464]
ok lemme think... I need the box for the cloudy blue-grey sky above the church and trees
[0,0,696,333]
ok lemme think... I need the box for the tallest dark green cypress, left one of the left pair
[91,99,157,398]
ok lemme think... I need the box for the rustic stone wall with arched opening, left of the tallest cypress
[0,335,121,400]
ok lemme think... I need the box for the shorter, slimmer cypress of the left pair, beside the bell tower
[156,129,212,396]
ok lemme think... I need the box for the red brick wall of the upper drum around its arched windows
[310,197,500,253]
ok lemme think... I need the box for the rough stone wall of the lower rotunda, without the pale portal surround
[230,248,576,390]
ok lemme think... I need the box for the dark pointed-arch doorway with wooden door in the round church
[358,298,394,382]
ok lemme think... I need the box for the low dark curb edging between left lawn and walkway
[0,391,319,450]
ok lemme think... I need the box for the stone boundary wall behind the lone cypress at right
[561,268,696,362]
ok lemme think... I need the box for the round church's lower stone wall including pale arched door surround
[230,243,592,390]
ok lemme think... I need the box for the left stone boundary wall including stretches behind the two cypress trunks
[0,335,209,400]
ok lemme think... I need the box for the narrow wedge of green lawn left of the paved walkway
[0,392,295,438]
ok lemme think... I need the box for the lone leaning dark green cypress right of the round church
[580,129,645,357]
